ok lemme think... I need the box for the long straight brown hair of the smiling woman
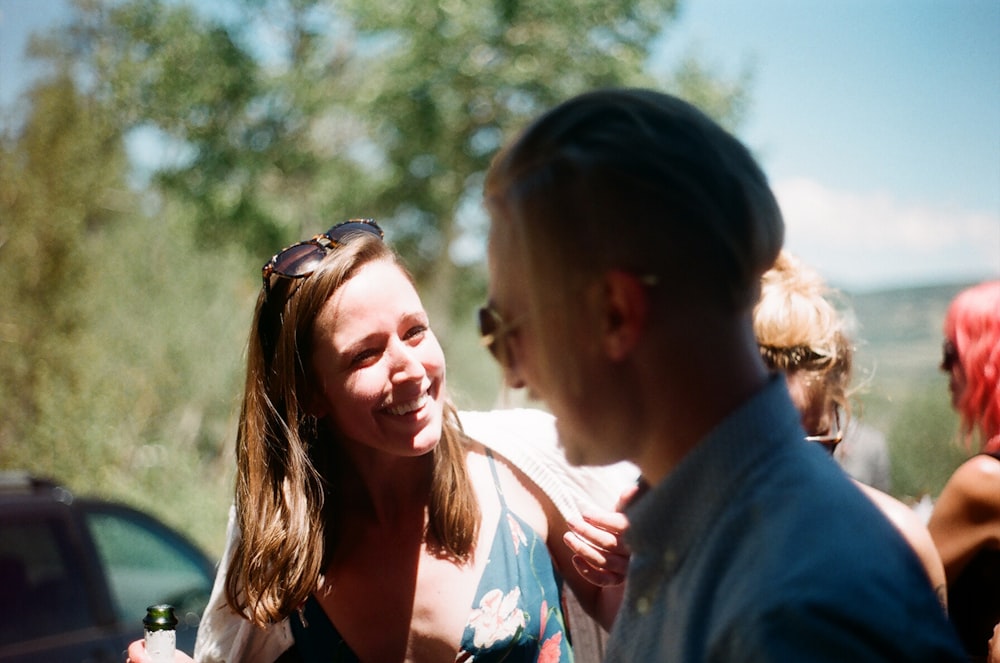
[226,234,480,626]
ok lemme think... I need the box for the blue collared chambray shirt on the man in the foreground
[605,375,964,663]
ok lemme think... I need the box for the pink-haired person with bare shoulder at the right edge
[928,281,1000,660]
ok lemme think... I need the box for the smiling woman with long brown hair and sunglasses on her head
[130,219,627,663]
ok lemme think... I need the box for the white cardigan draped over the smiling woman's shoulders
[194,409,639,663]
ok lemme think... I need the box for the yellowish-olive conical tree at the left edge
[0,71,130,463]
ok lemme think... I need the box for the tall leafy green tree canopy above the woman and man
[31,0,744,324]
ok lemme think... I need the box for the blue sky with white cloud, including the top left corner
[0,0,1000,291]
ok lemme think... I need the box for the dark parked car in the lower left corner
[0,473,215,663]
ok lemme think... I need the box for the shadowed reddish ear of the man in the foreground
[603,269,649,361]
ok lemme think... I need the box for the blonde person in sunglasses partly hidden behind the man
[754,251,946,604]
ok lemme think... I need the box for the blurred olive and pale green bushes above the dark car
[0,72,250,550]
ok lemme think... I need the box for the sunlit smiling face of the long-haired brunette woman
[310,261,445,456]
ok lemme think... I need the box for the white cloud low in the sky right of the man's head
[773,178,1000,290]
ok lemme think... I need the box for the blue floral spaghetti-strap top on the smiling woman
[290,450,573,663]
